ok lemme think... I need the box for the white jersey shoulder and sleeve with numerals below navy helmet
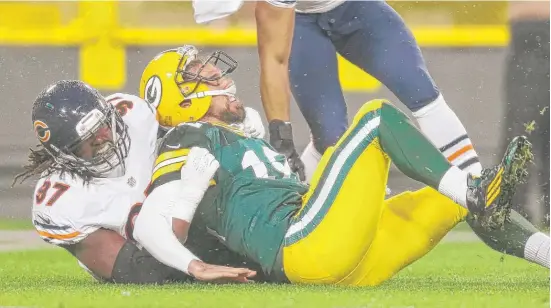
[32,174,144,245]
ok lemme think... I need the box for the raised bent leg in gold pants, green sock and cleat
[283,100,525,283]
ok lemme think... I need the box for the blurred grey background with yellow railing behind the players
[0,1,549,226]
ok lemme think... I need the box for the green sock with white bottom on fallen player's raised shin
[379,103,467,207]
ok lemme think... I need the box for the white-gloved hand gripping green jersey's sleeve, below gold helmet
[180,147,220,192]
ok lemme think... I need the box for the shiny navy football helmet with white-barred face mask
[32,80,130,177]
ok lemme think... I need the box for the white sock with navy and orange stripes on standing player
[413,94,482,175]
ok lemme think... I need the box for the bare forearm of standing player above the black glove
[255,2,295,121]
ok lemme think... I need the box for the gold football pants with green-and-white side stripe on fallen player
[282,100,467,286]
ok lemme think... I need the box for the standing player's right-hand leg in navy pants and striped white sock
[328,1,482,174]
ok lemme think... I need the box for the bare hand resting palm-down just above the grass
[188,260,256,283]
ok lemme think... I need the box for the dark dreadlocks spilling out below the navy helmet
[11,144,93,187]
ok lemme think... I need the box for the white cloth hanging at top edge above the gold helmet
[193,0,245,24]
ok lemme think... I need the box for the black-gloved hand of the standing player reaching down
[269,120,306,181]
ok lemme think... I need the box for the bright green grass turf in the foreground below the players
[0,243,549,308]
